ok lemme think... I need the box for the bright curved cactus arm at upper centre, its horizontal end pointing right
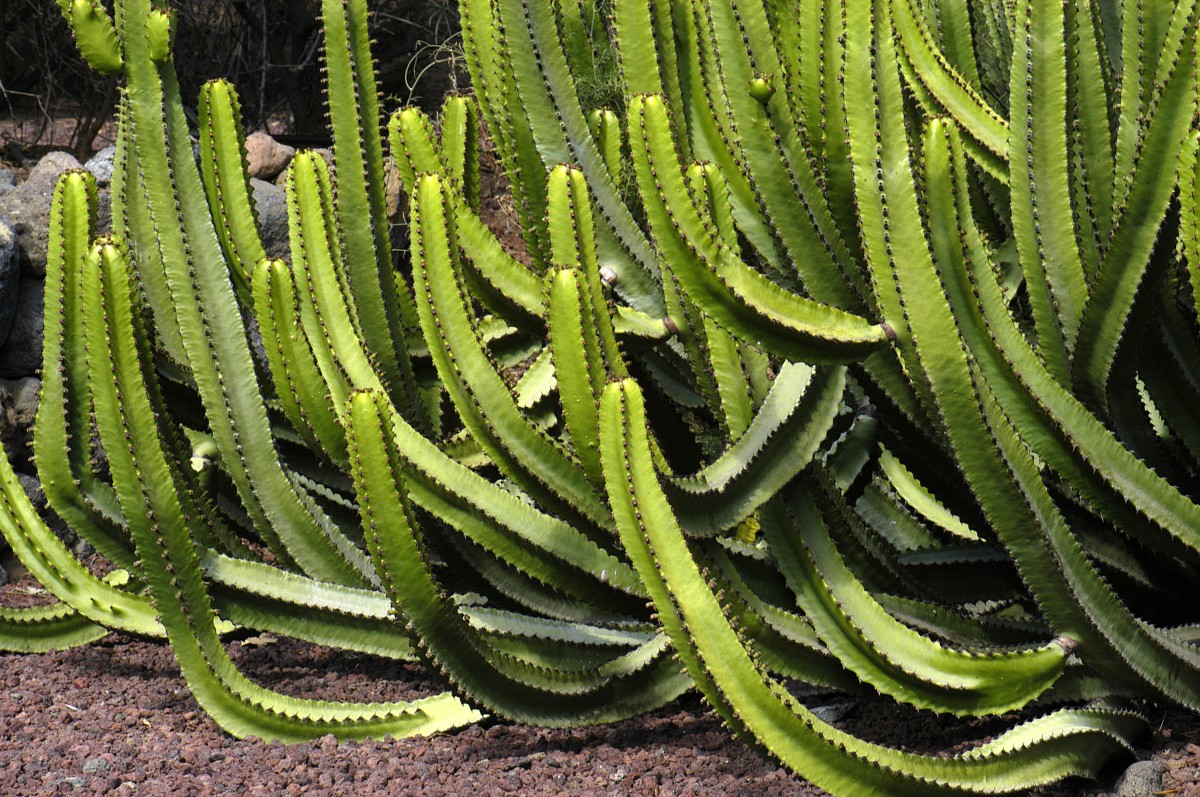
[629,96,887,362]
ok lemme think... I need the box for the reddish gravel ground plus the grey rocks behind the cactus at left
[0,136,1200,797]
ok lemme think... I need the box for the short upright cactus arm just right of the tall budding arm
[199,80,266,305]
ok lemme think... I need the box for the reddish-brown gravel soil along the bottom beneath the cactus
[0,568,1200,797]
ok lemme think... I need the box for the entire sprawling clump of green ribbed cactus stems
[0,0,1200,795]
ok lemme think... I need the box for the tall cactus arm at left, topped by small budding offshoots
[125,0,367,583]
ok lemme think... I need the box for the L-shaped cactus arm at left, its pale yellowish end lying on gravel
[84,236,479,741]
